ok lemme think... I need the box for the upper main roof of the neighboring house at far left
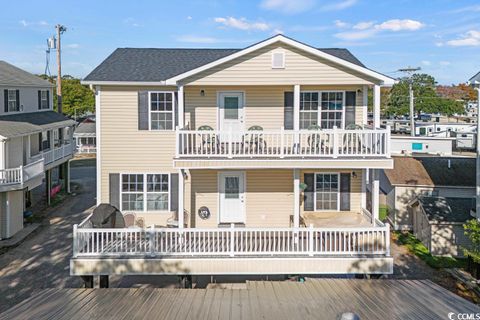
[0,60,53,88]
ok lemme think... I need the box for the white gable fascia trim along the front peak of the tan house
[165,35,396,86]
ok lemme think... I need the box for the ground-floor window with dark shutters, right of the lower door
[315,173,340,211]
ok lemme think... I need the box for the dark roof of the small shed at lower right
[418,197,475,223]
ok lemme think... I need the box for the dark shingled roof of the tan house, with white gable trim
[82,35,393,84]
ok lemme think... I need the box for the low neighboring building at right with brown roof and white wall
[380,156,475,230]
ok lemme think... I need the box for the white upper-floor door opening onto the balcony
[218,92,244,133]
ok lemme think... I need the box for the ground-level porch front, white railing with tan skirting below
[71,220,392,275]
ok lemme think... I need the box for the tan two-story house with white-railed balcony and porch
[71,35,394,284]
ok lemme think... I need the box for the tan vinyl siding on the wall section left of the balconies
[100,87,178,208]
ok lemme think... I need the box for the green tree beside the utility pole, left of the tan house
[40,75,95,117]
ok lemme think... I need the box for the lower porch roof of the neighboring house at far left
[0,111,75,138]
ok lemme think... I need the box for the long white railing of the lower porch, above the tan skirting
[73,221,390,258]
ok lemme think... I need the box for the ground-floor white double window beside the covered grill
[121,174,169,211]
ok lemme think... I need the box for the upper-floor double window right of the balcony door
[300,92,345,129]
